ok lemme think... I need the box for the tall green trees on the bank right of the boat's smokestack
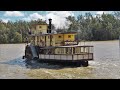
[67,11,120,40]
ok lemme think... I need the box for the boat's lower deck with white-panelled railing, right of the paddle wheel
[39,46,93,60]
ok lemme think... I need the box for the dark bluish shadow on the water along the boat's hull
[0,57,80,69]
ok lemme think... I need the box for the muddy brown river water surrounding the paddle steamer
[0,40,120,79]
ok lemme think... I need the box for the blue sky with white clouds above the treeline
[0,11,113,28]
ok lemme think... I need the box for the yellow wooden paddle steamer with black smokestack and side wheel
[25,19,93,66]
